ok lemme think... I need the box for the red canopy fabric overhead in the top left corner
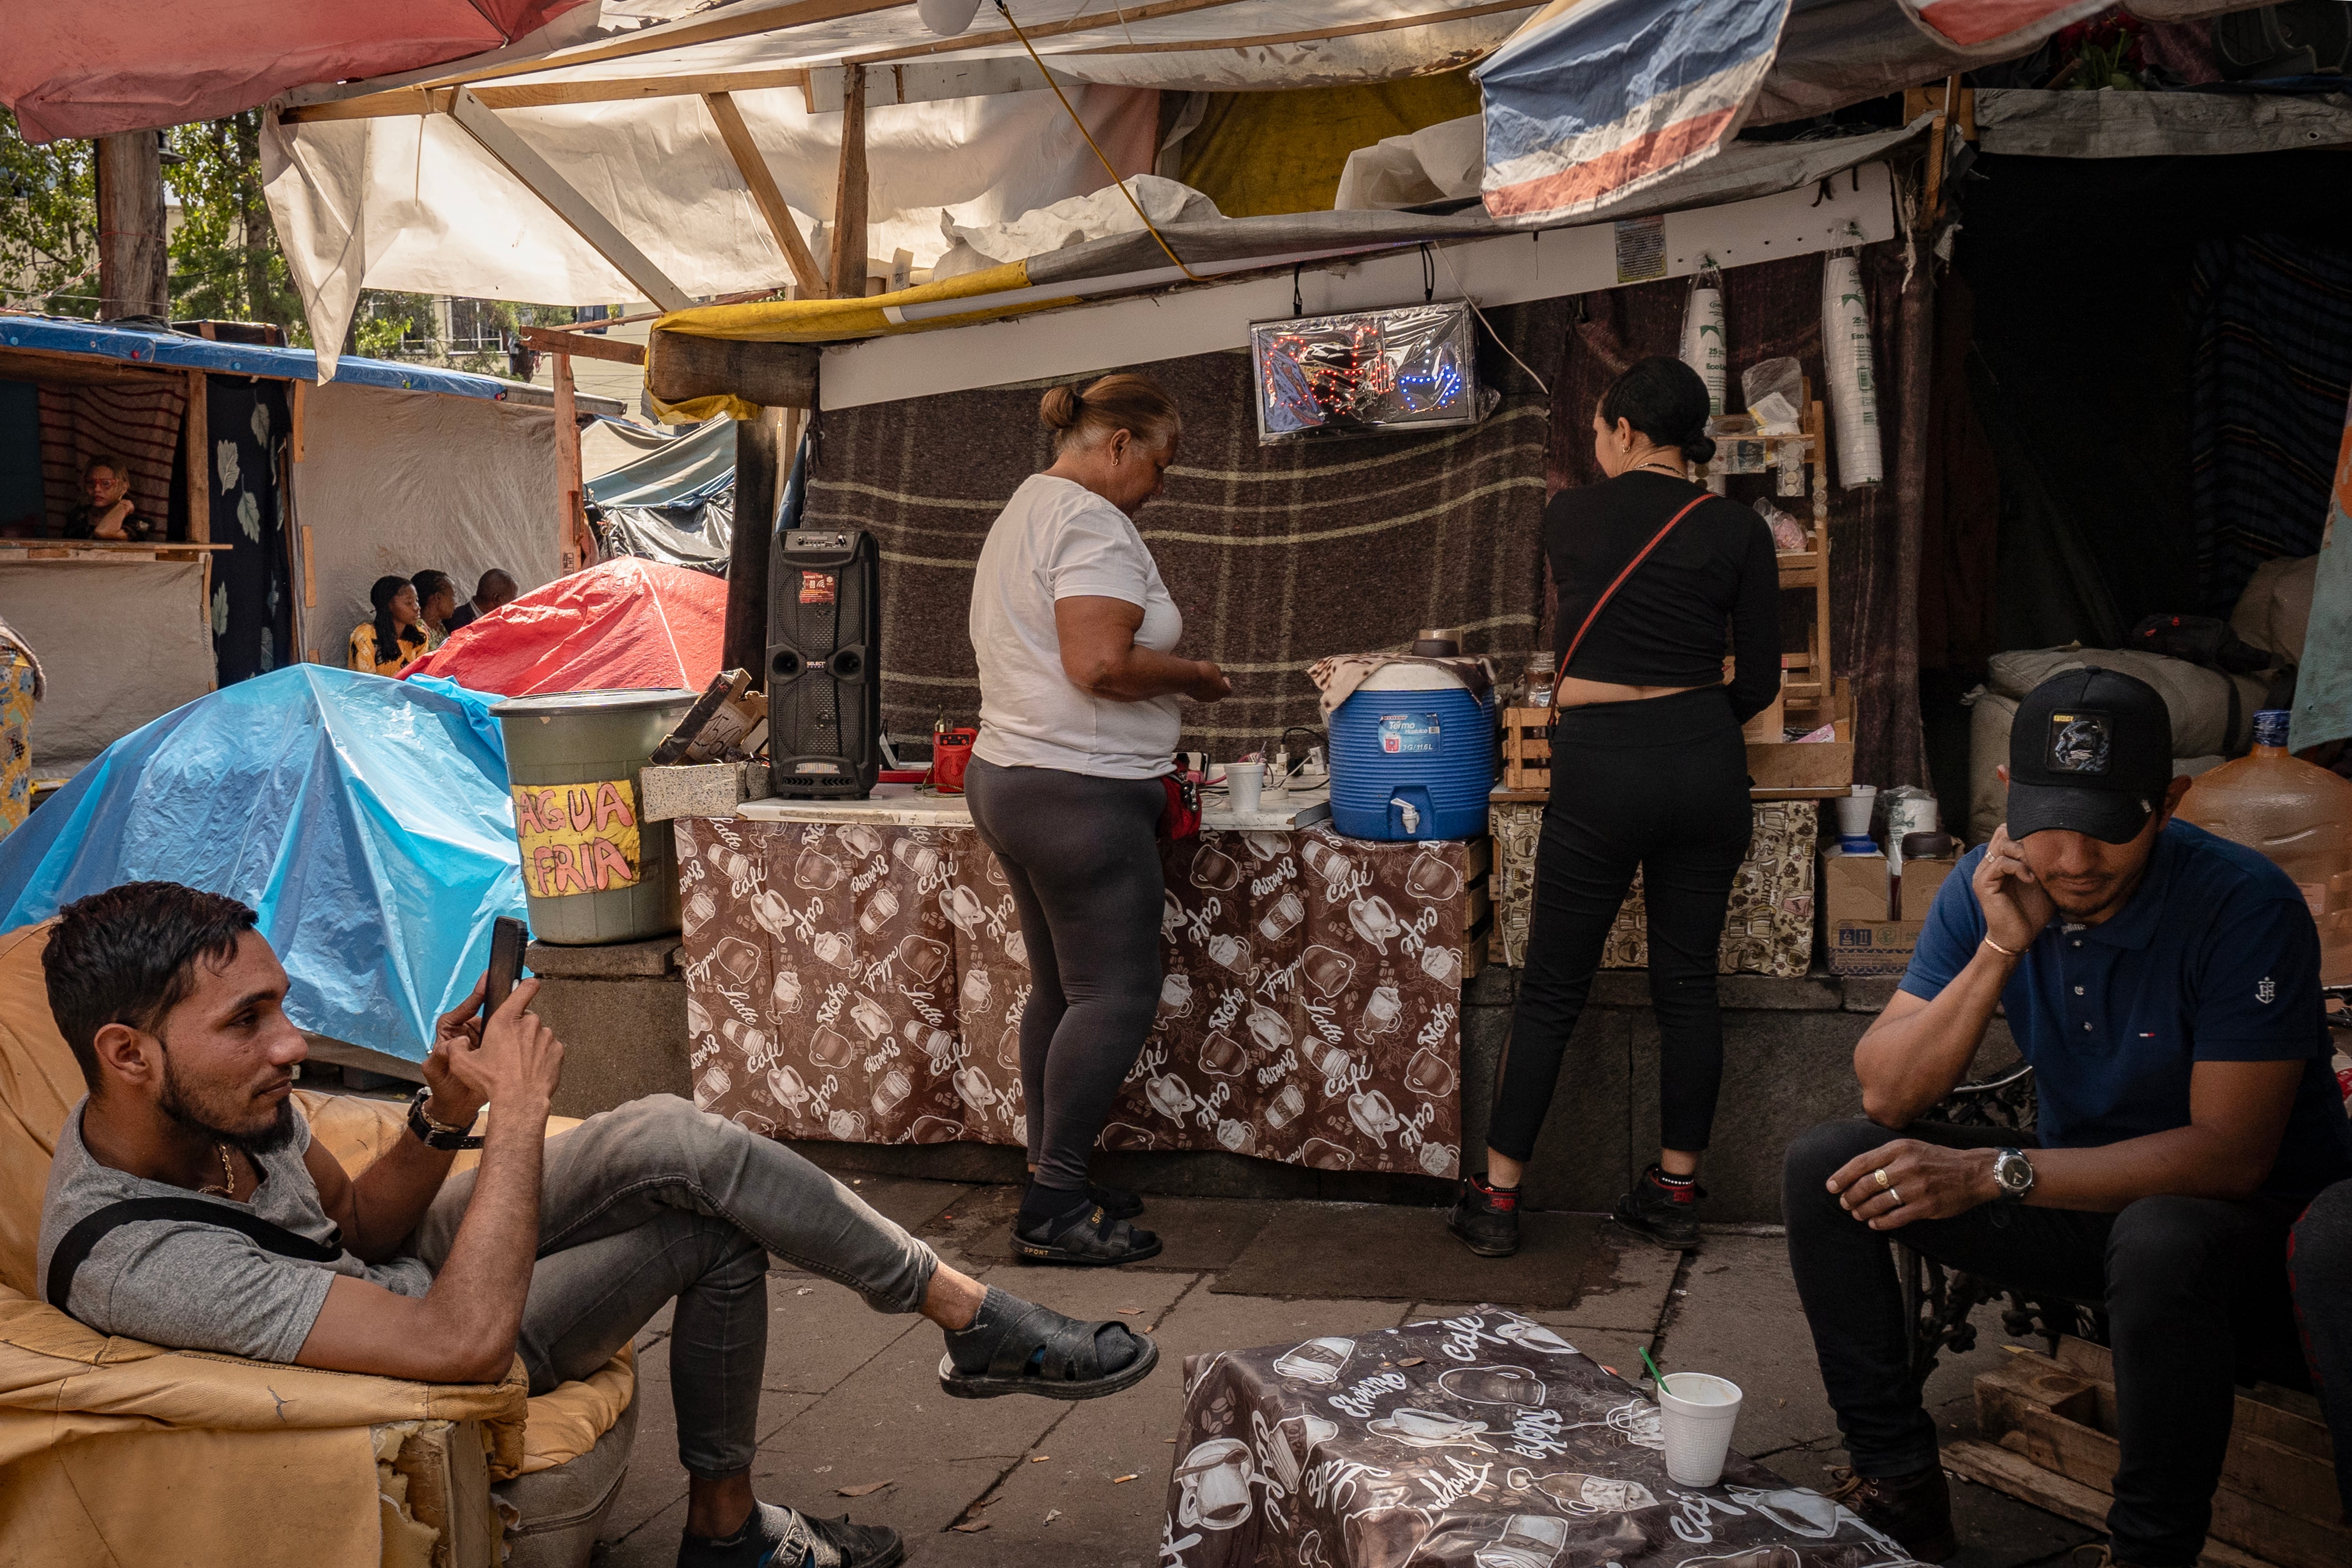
[0,0,581,141]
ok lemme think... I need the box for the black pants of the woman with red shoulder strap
[1486,686,1755,1159]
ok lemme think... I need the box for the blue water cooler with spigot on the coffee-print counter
[1331,665,1494,839]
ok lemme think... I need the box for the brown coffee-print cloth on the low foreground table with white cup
[1160,1307,1912,1568]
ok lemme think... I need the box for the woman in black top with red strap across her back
[1451,358,1780,1258]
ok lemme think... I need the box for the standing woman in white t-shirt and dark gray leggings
[964,376,1232,1265]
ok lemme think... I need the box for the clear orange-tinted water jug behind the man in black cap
[2180,708,2352,985]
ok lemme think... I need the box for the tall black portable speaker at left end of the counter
[767,529,882,799]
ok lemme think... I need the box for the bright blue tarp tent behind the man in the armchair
[0,665,524,1060]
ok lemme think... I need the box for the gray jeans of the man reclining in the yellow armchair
[409,1096,938,1479]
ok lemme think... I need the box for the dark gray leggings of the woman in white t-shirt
[964,757,1167,1192]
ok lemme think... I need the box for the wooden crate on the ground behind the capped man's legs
[1943,1337,2352,1568]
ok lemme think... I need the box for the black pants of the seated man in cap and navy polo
[1780,1122,2305,1568]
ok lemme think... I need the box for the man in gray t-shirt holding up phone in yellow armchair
[38,882,1160,1568]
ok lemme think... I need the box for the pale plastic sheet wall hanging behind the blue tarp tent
[292,381,560,665]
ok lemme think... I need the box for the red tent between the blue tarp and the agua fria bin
[400,555,727,696]
